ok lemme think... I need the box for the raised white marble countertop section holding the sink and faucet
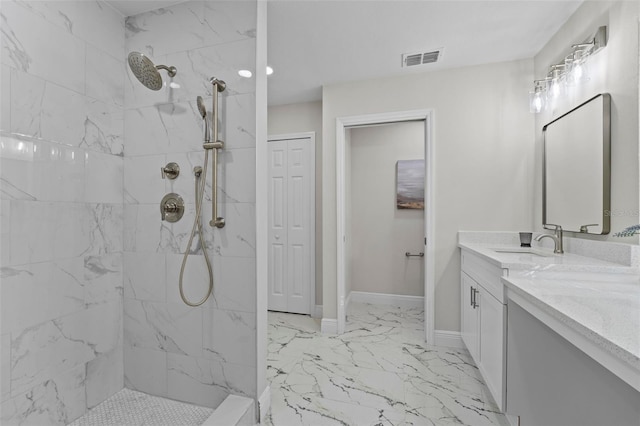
[458,242,638,274]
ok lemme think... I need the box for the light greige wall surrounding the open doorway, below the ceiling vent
[322,60,534,330]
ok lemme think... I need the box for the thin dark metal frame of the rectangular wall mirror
[542,93,611,235]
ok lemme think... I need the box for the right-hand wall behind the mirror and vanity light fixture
[534,1,640,244]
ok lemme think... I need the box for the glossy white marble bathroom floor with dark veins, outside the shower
[266,304,508,426]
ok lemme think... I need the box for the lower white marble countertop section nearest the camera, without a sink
[502,272,640,389]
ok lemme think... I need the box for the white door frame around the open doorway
[336,109,435,344]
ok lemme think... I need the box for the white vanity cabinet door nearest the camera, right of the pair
[476,287,507,410]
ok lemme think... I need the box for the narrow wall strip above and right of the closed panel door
[268,101,322,305]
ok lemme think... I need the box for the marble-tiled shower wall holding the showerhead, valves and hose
[124,1,256,407]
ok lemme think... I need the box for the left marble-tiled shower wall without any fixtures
[0,1,125,424]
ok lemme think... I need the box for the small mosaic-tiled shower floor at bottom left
[69,389,213,426]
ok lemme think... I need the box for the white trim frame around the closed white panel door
[267,132,317,316]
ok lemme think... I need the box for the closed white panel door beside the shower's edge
[268,138,315,314]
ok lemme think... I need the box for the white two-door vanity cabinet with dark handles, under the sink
[460,249,508,411]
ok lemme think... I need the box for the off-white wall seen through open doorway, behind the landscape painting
[345,121,425,296]
